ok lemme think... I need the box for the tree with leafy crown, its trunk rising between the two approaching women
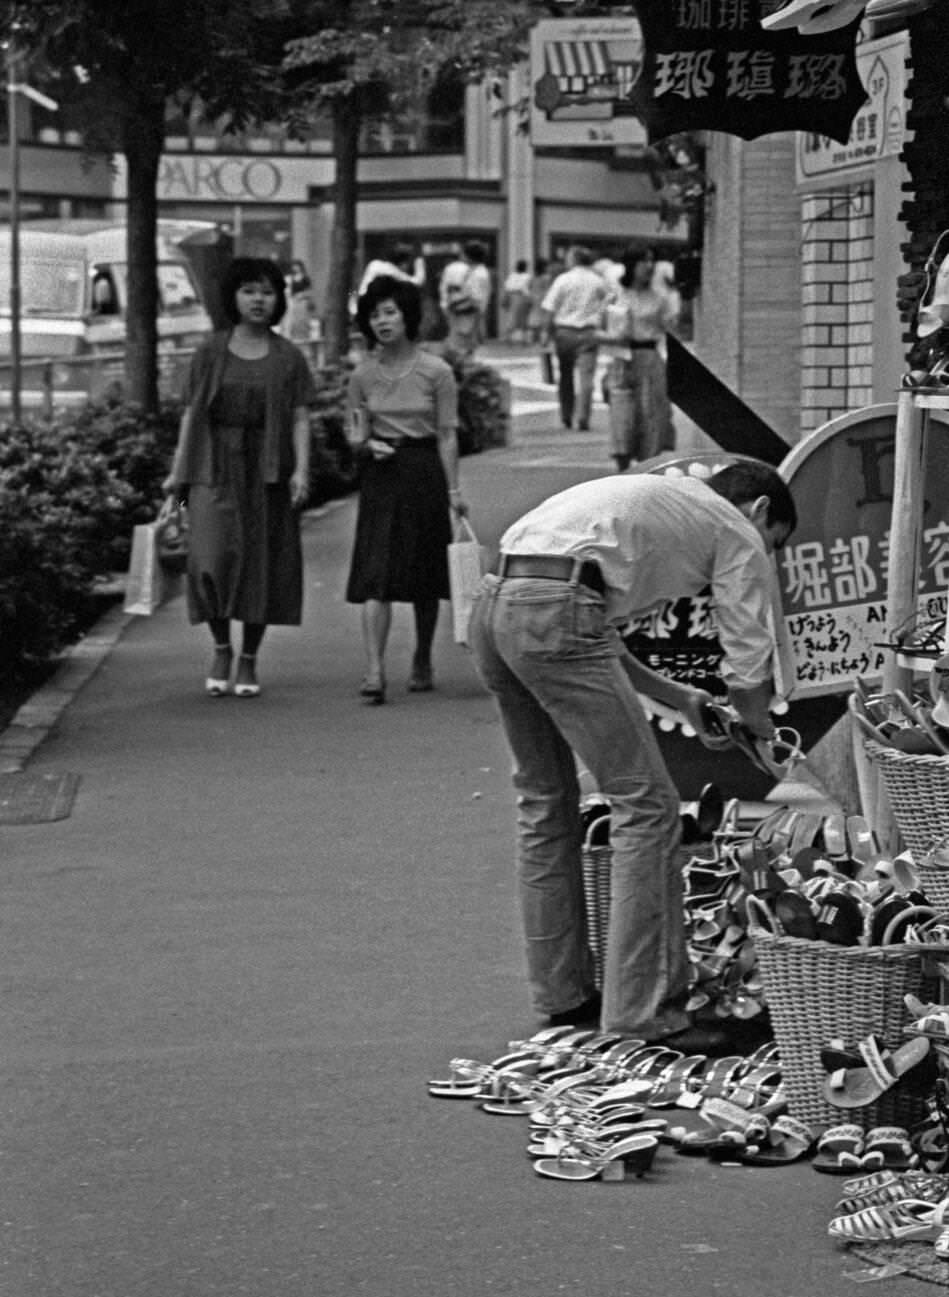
[285,0,550,362]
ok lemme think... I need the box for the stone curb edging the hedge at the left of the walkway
[0,606,134,774]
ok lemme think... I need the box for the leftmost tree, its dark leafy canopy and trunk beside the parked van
[0,0,301,410]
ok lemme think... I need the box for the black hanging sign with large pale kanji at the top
[635,0,866,143]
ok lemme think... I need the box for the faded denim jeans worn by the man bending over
[469,576,688,1040]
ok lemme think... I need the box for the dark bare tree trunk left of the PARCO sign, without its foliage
[122,101,165,411]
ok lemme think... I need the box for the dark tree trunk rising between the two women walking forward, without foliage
[325,95,360,364]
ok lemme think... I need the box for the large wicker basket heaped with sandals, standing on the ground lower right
[753,929,936,1130]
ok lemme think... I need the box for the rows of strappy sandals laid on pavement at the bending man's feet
[428,1026,814,1180]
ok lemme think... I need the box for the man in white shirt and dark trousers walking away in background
[541,245,609,432]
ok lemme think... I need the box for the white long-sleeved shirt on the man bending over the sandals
[500,473,774,689]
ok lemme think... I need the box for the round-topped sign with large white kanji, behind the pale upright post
[778,405,949,698]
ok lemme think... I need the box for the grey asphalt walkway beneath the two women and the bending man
[0,363,919,1297]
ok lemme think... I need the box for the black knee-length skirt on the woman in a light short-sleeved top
[346,437,451,603]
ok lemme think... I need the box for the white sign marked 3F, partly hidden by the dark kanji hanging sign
[797,31,909,184]
